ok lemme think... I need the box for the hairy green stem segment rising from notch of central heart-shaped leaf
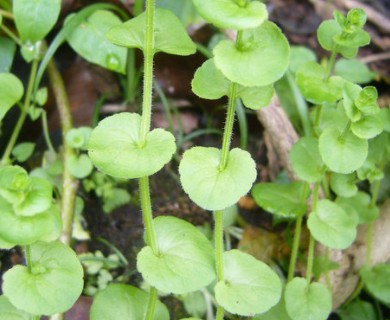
[219,83,237,171]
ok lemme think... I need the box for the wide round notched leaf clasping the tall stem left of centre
[88,112,176,179]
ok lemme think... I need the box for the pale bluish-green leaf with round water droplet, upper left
[67,10,127,73]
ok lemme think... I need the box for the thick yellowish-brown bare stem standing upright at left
[47,60,79,245]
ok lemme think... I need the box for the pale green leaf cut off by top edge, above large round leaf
[193,0,268,30]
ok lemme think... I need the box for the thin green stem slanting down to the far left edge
[1,60,38,165]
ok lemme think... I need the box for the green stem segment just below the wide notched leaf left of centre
[139,177,159,256]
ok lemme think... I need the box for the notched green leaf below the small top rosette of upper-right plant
[296,62,345,104]
